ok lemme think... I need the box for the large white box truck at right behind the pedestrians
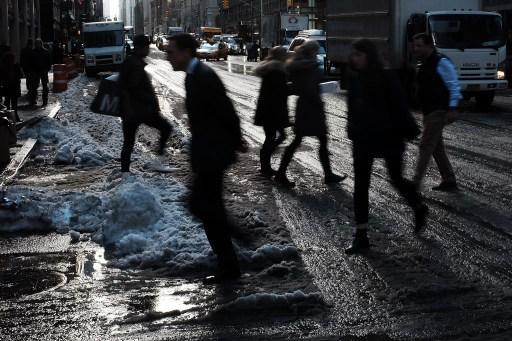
[326,0,508,108]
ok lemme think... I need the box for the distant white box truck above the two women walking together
[261,13,309,48]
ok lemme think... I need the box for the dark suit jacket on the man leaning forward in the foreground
[185,62,242,172]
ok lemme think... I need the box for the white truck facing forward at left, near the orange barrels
[82,21,126,76]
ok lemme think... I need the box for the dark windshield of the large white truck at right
[429,14,505,49]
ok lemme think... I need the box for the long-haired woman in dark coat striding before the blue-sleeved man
[345,40,428,254]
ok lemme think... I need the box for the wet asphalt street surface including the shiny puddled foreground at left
[0,50,512,341]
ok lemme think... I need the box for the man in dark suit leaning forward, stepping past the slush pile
[167,34,243,284]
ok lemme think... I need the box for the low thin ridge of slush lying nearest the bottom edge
[212,290,325,315]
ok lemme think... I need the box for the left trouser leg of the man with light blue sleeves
[414,110,446,187]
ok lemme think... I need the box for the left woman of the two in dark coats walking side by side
[254,47,290,176]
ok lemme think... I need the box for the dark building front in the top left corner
[0,0,41,60]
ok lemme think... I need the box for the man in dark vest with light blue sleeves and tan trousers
[413,33,462,191]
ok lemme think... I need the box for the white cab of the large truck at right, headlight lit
[407,11,508,108]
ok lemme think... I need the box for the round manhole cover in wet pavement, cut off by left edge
[0,269,67,299]
